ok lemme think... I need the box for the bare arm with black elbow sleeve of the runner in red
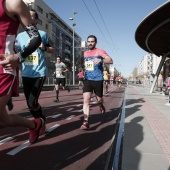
[0,0,41,70]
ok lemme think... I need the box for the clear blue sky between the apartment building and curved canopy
[44,0,167,77]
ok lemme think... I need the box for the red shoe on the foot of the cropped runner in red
[29,118,42,144]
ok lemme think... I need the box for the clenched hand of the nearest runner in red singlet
[0,54,19,71]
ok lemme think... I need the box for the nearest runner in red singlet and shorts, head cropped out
[0,0,42,144]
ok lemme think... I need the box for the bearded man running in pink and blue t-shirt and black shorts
[80,35,113,129]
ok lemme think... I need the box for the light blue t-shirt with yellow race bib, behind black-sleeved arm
[15,30,49,78]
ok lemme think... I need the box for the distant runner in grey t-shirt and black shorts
[53,56,70,102]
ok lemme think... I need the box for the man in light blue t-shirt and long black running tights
[15,9,54,135]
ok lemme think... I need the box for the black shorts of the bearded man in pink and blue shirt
[83,80,103,97]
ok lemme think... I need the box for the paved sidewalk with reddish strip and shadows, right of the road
[121,85,170,170]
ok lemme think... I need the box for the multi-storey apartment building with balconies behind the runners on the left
[19,0,82,83]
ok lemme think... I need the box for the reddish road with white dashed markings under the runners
[0,86,125,170]
